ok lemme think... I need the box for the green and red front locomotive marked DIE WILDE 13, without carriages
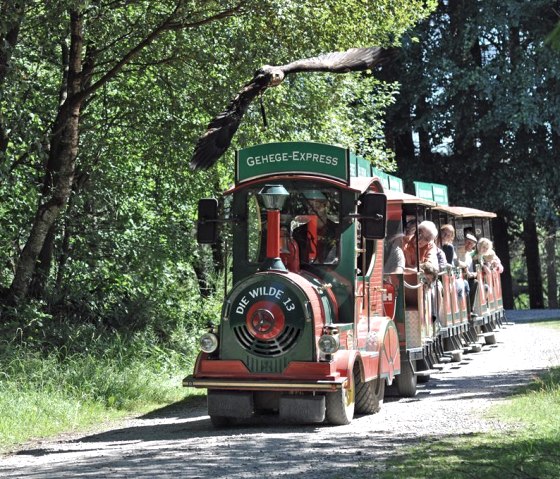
[183,143,400,425]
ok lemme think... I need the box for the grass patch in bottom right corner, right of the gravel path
[379,322,560,479]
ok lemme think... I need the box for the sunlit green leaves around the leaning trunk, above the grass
[0,0,435,330]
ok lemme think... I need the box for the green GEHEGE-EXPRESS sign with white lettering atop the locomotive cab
[236,142,349,183]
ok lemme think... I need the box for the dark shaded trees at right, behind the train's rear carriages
[382,0,560,307]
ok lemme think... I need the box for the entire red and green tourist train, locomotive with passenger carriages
[183,142,504,426]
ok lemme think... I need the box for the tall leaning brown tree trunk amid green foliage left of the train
[8,12,84,303]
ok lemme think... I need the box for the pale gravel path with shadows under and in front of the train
[0,323,560,479]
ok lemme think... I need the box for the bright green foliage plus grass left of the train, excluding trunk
[0,0,436,454]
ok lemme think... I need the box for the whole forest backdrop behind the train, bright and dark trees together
[0,0,560,446]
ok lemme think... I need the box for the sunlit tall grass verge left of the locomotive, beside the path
[0,337,202,452]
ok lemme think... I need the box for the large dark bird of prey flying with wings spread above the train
[190,47,394,170]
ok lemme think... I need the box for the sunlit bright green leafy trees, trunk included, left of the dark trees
[0,0,438,322]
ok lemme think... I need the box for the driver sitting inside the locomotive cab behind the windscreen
[292,190,340,264]
